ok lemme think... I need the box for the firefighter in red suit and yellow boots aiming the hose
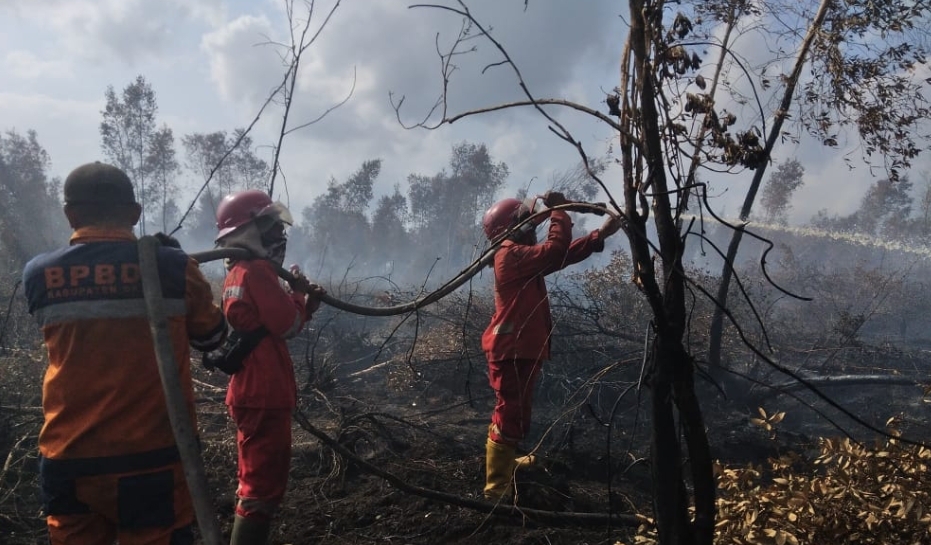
[482,192,621,501]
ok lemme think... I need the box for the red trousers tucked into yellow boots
[488,359,543,447]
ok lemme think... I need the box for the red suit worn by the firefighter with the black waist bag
[223,260,308,519]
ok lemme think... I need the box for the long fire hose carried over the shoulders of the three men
[131,202,617,545]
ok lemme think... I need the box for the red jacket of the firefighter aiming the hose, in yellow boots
[482,210,604,361]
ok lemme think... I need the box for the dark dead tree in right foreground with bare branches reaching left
[394,0,715,545]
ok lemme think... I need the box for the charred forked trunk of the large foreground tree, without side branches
[621,0,716,545]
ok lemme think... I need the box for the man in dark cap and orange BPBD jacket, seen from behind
[23,163,226,545]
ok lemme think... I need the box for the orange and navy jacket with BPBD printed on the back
[23,228,226,462]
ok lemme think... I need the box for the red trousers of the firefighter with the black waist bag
[229,406,291,519]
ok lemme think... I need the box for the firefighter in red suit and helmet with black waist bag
[217,190,325,545]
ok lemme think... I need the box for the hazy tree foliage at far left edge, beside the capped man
[0,130,68,271]
